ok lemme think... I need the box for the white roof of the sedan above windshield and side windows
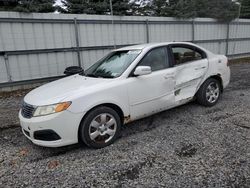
[115,42,195,51]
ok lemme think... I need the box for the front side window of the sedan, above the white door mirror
[139,47,169,71]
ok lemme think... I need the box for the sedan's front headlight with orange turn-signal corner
[33,102,71,117]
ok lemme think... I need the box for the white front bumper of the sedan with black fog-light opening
[19,110,83,147]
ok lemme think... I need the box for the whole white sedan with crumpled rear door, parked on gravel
[19,42,230,148]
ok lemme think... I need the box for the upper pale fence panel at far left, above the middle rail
[0,22,75,51]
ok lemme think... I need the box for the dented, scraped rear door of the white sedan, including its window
[169,44,208,104]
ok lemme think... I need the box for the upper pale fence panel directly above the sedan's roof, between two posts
[149,24,192,42]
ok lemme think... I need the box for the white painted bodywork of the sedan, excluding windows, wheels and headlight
[19,42,230,147]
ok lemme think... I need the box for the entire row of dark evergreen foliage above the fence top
[0,0,246,22]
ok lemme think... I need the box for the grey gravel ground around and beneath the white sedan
[0,63,250,187]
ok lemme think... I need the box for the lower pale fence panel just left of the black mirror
[9,52,77,81]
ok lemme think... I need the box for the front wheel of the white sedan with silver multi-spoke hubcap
[79,106,121,149]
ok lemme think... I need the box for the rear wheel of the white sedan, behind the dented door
[196,78,222,107]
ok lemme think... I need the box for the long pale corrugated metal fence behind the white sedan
[0,12,250,88]
